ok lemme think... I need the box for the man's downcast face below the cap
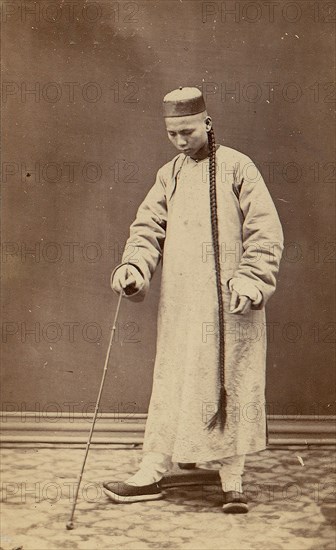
[165,113,208,156]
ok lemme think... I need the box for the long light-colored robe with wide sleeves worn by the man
[113,146,283,462]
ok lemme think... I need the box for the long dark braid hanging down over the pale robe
[207,128,227,431]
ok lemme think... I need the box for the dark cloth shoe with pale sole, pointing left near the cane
[103,481,163,503]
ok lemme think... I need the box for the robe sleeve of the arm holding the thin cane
[111,170,167,301]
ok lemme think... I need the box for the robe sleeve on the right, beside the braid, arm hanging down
[229,158,283,309]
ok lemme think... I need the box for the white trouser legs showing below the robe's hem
[126,452,245,492]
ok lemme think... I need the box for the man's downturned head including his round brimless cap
[163,88,212,157]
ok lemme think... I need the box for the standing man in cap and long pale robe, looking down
[104,88,283,513]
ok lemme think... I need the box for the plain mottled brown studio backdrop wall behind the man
[1,0,335,415]
